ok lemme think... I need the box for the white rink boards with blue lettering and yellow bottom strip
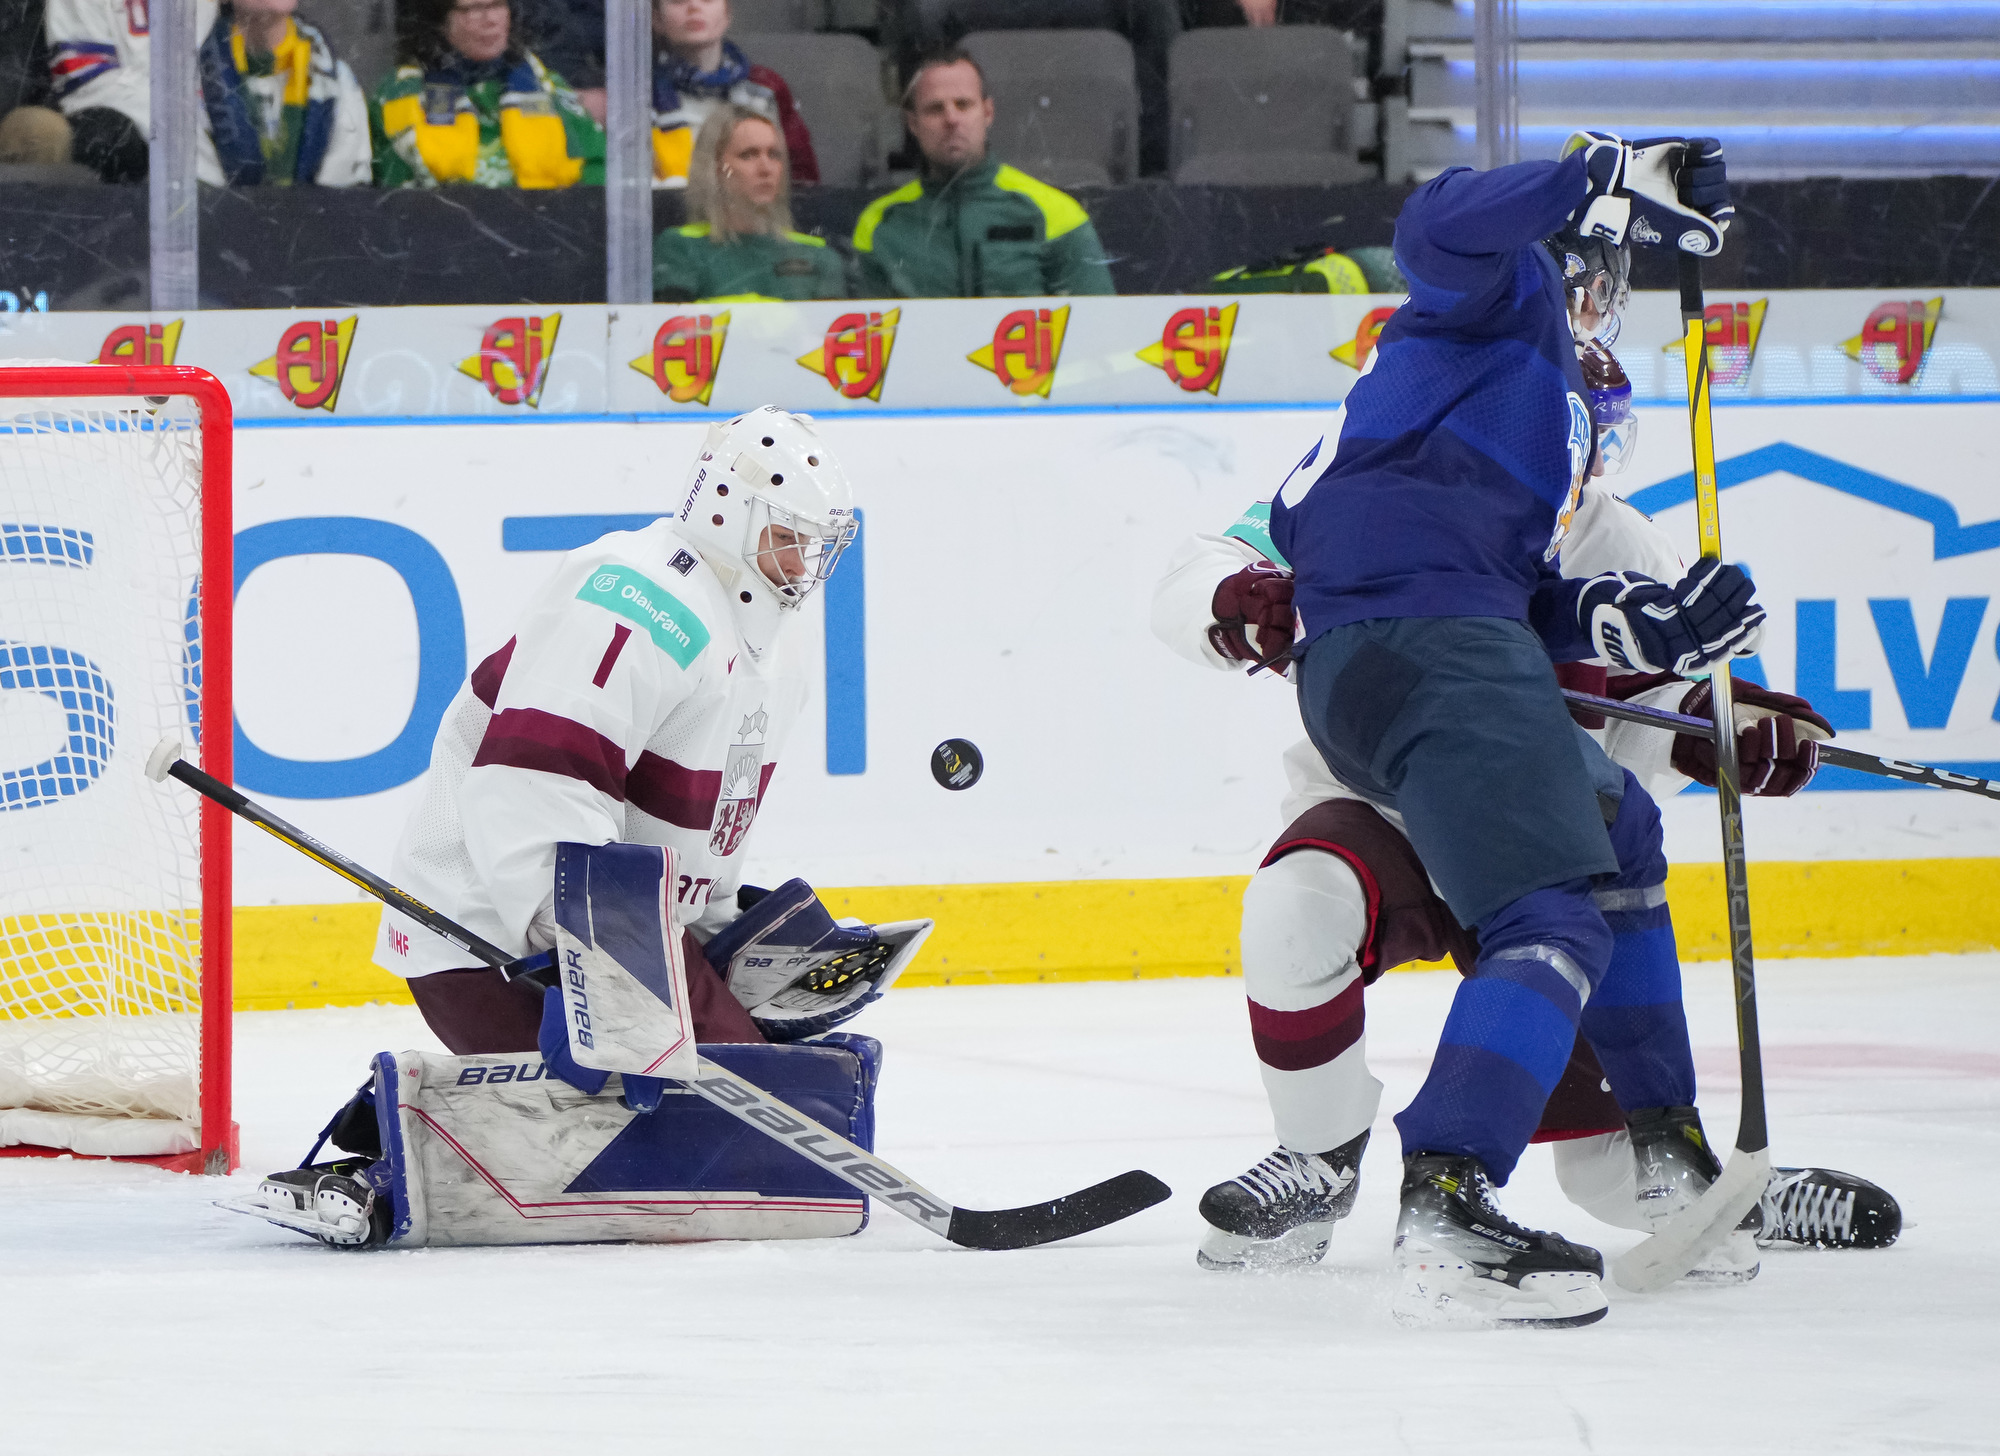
[11,294,2000,1006]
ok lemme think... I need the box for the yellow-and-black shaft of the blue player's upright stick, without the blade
[1676,252,1770,1152]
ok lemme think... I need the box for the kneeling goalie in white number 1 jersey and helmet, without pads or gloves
[376,406,854,1054]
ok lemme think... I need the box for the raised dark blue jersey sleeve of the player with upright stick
[1396,152,1588,314]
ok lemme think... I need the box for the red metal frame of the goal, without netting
[0,364,238,1174]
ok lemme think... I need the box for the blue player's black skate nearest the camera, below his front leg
[1392,1154,1608,1330]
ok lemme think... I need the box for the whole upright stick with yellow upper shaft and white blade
[1612,252,1770,1292]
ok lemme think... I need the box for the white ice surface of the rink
[0,956,2000,1456]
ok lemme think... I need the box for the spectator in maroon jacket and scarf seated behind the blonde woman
[652,0,820,188]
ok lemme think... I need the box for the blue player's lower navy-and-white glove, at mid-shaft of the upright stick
[1576,558,1764,678]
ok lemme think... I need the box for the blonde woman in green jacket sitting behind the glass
[652,102,848,302]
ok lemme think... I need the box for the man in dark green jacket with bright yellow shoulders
[854,50,1116,298]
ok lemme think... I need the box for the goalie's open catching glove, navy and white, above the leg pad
[704,880,936,1042]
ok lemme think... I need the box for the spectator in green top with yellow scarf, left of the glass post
[372,0,604,188]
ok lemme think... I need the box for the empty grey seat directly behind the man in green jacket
[962,30,1138,186]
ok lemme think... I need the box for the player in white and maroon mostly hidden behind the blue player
[1154,348,1900,1304]
